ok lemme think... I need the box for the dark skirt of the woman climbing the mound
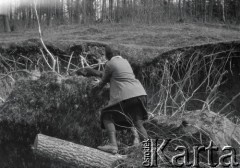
[100,96,148,130]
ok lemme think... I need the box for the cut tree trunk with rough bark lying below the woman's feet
[33,134,124,168]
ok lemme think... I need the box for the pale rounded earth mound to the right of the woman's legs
[155,110,240,148]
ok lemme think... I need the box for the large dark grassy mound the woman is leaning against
[0,72,107,146]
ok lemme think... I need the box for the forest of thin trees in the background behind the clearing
[0,0,240,32]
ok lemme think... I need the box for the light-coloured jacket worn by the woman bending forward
[102,56,147,107]
